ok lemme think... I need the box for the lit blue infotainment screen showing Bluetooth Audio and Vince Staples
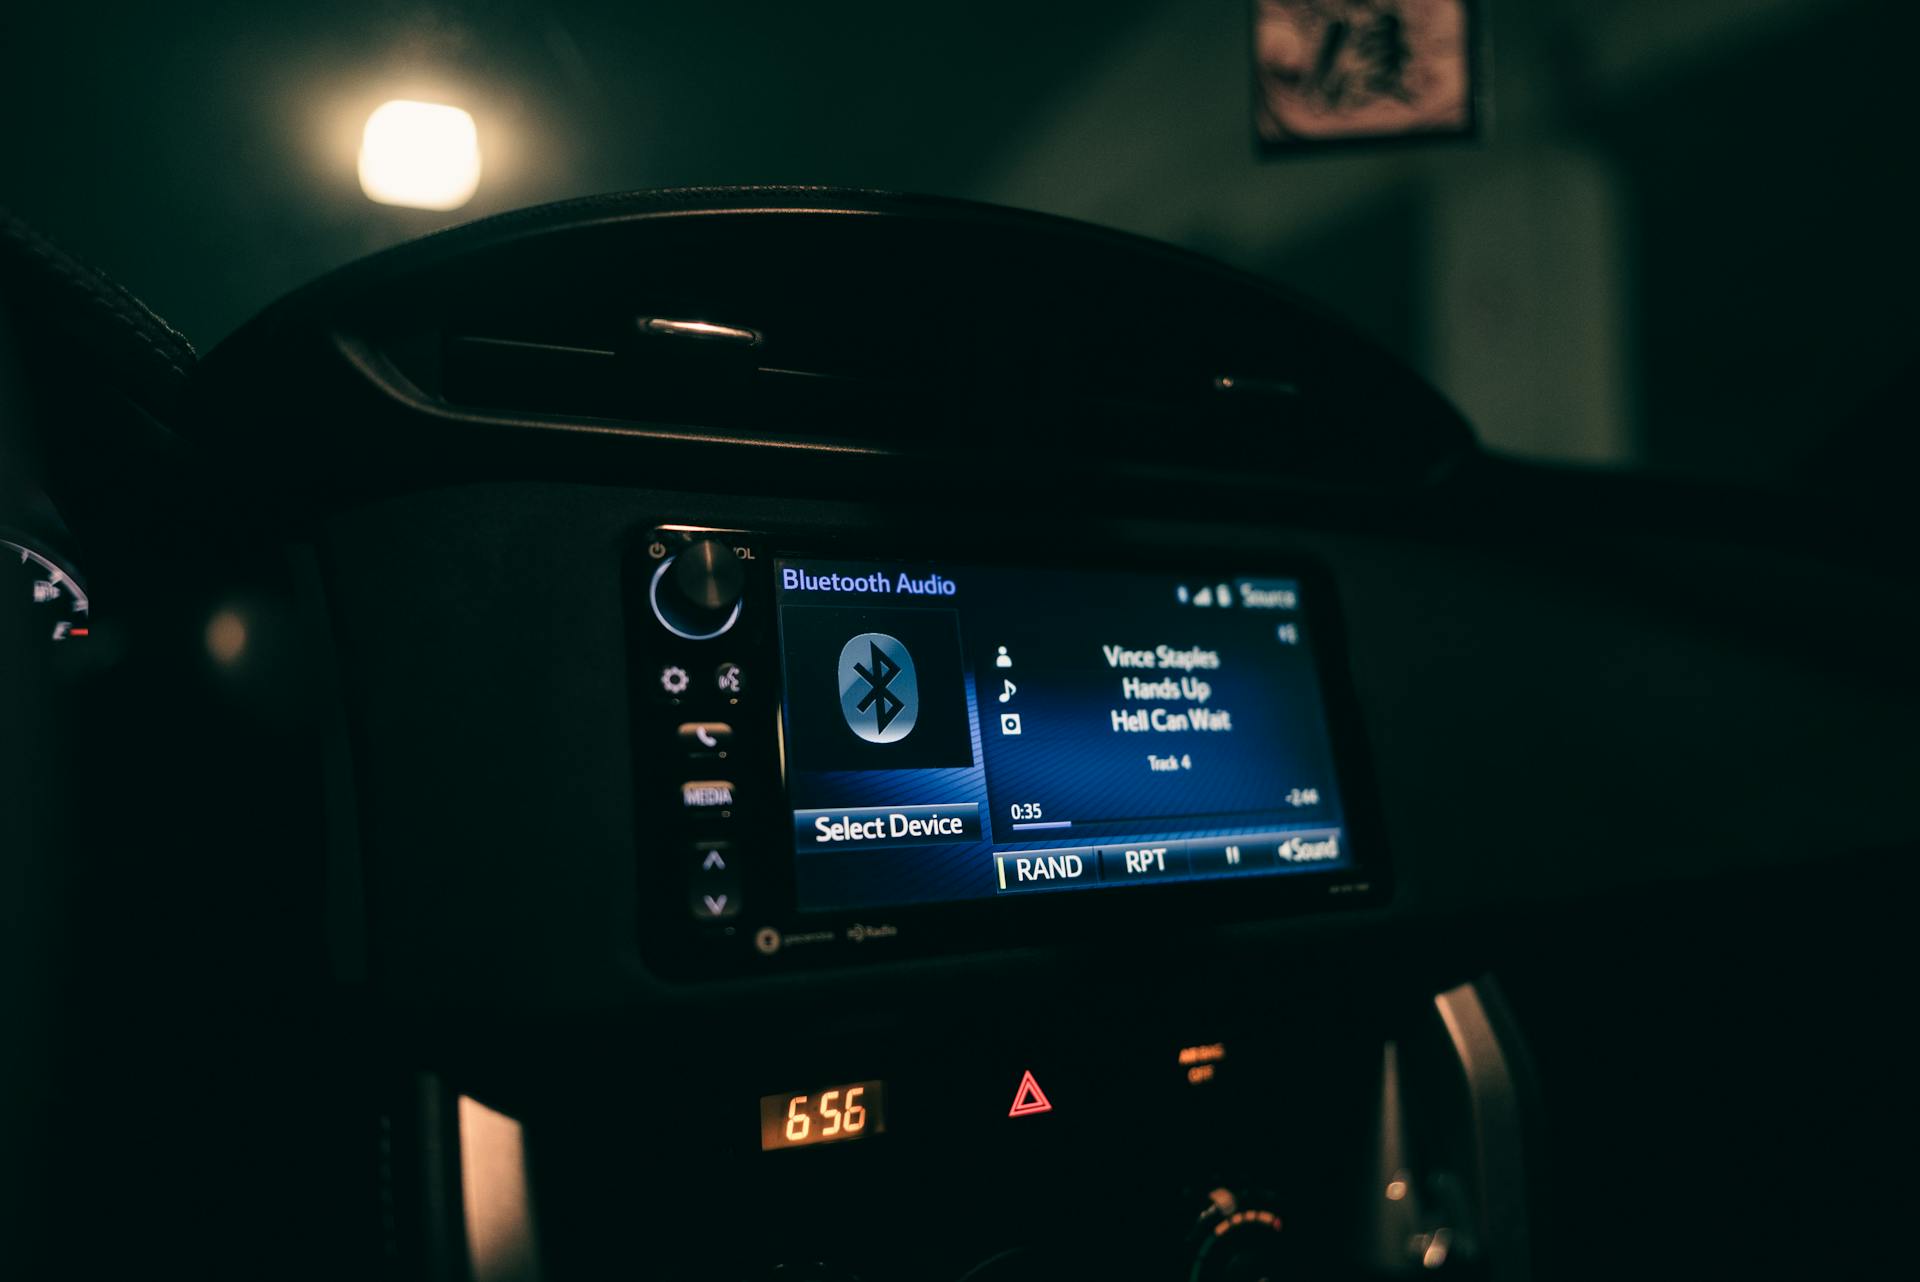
[774,558,1354,912]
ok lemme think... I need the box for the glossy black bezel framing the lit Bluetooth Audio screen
[636,524,1392,975]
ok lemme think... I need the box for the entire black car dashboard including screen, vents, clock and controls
[0,188,1920,1282]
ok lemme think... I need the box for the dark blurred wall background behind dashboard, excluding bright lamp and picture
[0,0,1920,486]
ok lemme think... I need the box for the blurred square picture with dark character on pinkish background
[1254,0,1478,152]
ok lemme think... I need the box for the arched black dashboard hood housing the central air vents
[288,192,1471,484]
